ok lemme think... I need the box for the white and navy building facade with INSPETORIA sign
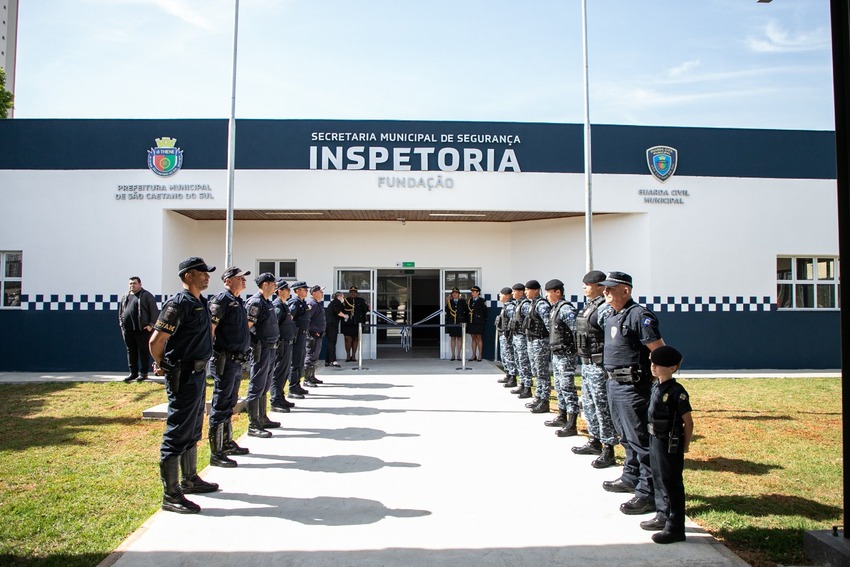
[0,120,840,371]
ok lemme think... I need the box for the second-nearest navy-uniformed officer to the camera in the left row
[209,266,251,467]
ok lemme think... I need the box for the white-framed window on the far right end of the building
[776,256,840,309]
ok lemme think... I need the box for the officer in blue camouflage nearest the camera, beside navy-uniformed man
[572,270,616,469]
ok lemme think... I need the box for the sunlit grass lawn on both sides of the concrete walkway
[0,379,844,567]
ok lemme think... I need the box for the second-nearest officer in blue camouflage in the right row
[544,279,579,437]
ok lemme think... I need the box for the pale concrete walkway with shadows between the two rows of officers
[9,360,746,567]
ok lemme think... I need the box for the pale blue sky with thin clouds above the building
[8,0,835,130]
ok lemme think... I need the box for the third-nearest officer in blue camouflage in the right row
[522,280,552,413]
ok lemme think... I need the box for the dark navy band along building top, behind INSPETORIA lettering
[0,119,835,179]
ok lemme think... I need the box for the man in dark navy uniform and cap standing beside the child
[601,272,664,514]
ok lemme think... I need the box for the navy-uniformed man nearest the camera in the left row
[150,256,218,514]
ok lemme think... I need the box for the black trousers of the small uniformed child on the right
[649,435,685,534]
